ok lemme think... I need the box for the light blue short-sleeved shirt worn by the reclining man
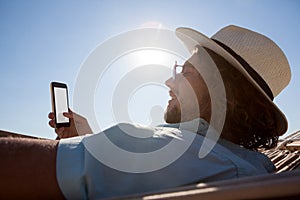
[57,119,275,199]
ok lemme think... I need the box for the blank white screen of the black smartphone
[54,87,69,123]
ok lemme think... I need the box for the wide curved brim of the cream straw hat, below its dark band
[176,27,288,136]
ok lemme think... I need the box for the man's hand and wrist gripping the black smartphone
[48,109,93,138]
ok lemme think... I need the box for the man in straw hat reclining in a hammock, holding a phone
[0,26,290,199]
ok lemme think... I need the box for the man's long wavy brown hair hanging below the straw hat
[206,49,278,150]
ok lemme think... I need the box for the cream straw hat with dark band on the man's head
[176,25,291,135]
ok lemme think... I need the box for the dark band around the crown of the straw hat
[212,39,274,101]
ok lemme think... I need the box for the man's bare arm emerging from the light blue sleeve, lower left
[0,137,64,199]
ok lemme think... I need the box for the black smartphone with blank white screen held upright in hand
[50,82,70,128]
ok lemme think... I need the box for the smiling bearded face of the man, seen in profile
[164,54,210,123]
